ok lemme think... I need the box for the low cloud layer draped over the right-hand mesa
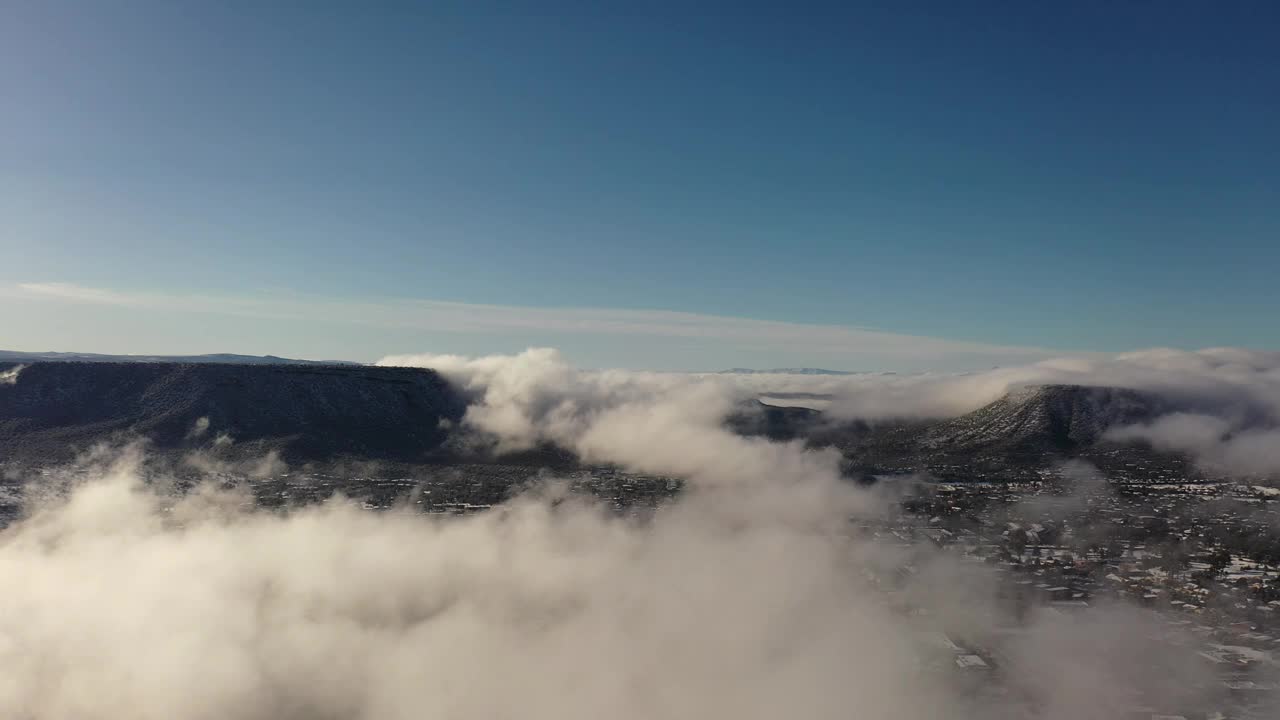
[716,348,1280,475]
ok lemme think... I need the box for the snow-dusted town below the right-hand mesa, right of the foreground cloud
[851,473,1280,720]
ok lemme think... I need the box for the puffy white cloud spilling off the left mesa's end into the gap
[383,348,854,517]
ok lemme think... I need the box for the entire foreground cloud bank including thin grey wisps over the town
[0,430,1239,720]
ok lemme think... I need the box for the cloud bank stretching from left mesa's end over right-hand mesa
[381,348,1280,479]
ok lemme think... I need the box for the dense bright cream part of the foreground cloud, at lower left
[0,448,921,720]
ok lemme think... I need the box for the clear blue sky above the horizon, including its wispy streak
[0,1,1280,369]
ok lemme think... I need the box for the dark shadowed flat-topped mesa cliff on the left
[0,363,465,462]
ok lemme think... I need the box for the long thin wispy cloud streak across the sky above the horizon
[4,282,1062,361]
